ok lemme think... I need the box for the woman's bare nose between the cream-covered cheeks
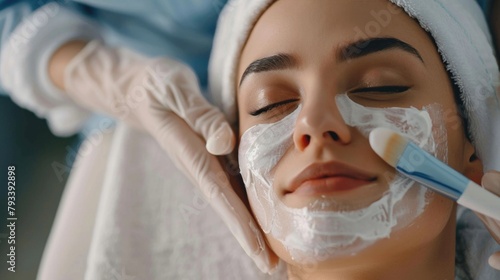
[293,98,351,151]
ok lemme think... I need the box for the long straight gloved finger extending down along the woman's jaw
[146,112,280,272]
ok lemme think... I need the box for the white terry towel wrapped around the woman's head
[209,0,500,170]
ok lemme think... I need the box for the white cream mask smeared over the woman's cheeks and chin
[238,94,447,263]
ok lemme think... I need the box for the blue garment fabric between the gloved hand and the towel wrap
[68,0,227,88]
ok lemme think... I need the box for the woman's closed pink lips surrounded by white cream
[285,161,377,195]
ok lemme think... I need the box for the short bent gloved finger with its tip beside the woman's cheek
[144,58,235,155]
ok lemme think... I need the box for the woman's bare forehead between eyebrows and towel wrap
[238,0,441,82]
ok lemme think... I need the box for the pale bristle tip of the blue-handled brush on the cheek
[369,127,408,167]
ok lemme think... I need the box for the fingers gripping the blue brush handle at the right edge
[476,171,500,270]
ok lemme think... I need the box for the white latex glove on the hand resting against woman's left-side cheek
[64,41,271,272]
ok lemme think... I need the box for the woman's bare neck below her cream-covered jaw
[288,210,456,280]
